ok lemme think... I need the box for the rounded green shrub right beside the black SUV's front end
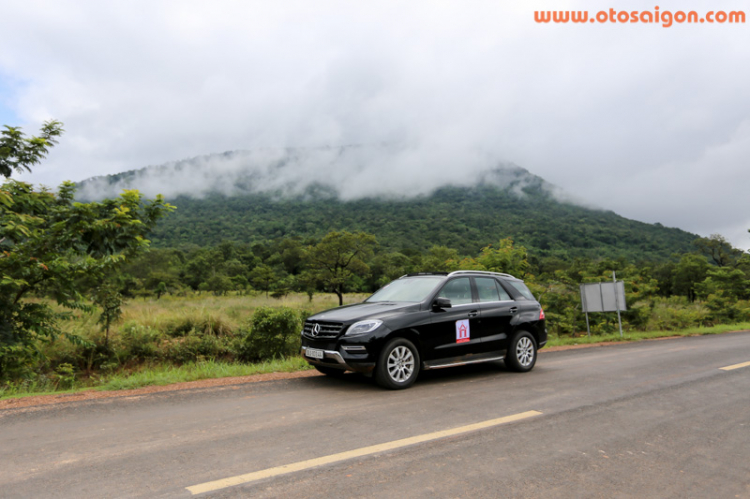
[241,307,302,360]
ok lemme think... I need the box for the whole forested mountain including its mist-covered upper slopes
[80,150,698,260]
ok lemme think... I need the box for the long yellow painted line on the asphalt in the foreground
[186,411,542,495]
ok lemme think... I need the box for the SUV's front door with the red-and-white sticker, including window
[423,277,481,362]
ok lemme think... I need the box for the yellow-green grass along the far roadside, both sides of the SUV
[0,294,750,398]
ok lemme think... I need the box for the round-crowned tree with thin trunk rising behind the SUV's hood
[307,231,377,305]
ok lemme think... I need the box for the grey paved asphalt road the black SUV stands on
[0,333,750,498]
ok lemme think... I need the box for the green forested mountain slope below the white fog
[153,186,698,260]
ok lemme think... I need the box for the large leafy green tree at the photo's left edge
[0,122,174,379]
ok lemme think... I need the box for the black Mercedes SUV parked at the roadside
[301,270,547,389]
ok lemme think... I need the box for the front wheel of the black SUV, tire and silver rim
[375,338,420,390]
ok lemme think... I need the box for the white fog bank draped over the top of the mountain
[78,146,572,202]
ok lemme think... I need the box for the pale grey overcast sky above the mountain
[0,0,750,249]
